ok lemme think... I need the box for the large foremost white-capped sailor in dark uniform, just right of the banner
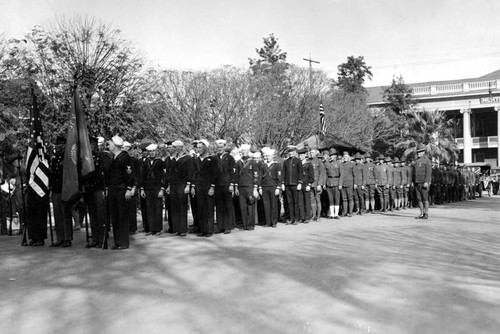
[106,136,136,249]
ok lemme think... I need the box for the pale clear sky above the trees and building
[0,0,500,87]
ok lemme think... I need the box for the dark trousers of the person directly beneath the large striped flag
[26,187,49,240]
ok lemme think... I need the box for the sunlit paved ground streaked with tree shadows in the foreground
[0,196,500,334]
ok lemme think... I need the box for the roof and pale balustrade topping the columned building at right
[366,70,500,104]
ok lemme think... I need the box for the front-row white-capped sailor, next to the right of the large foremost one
[139,144,165,235]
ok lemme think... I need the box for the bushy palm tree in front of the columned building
[396,109,458,162]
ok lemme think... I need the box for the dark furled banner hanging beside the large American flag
[61,88,95,202]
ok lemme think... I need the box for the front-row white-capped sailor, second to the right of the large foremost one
[167,140,194,237]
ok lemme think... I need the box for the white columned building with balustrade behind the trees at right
[367,70,500,166]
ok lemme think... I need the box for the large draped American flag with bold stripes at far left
[26,89,50,197]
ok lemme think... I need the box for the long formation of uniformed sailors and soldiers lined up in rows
[3,136,492,250]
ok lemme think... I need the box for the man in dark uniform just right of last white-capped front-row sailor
[281,147,304,225]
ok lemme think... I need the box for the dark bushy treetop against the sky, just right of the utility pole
[335,56,373,93]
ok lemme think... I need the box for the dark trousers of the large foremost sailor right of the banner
[108,185,130,247]
